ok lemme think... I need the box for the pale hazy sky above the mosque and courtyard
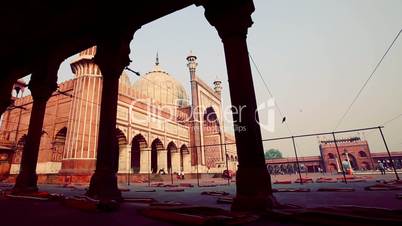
[26,0,402,156]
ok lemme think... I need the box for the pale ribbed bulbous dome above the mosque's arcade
[133,64,189,107]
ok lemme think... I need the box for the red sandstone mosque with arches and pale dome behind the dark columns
[0,47,237,183]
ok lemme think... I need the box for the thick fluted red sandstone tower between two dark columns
[61,46,102,176]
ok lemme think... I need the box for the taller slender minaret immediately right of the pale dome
[186,52,205,168]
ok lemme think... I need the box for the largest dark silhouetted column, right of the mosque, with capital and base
[204,0,274,211]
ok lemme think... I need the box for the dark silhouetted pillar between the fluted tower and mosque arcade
[87,32,134,200]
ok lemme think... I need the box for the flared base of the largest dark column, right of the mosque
[232,166,277,212]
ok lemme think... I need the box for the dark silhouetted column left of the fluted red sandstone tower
[13,62,60,193]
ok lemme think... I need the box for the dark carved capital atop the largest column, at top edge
[203,0,255,41]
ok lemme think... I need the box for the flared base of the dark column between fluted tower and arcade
[86,170,122,201]
